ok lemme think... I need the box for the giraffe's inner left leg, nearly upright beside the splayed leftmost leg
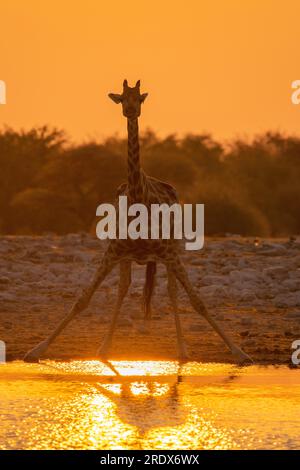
[97,261,131,357]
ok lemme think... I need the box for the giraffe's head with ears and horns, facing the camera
[108,80,148,119]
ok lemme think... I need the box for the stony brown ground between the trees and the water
[0,234,300,363]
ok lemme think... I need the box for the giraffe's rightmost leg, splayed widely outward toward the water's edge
[171,258,253,364]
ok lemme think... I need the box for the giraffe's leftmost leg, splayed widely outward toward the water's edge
[24,254,114,362]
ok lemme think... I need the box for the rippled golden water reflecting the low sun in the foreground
[0,361,300,449]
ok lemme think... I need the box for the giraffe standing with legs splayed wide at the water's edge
[24,80,252,363]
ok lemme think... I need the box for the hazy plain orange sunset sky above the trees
[0,0,300,141]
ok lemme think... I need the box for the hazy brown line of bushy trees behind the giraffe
[0,127,300,236]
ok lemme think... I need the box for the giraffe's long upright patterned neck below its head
[127,118,144,204]
